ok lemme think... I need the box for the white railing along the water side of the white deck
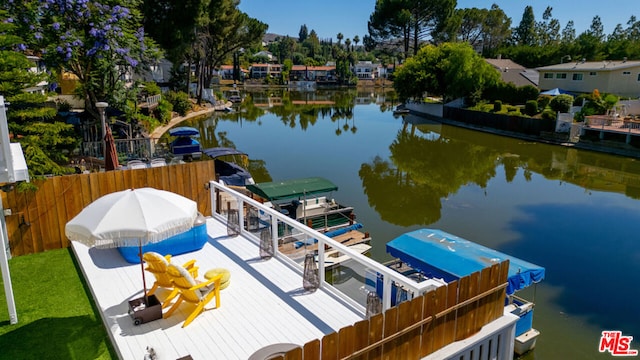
[209,181,444,311]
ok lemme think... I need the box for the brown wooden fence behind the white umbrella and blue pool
[2,161,215,256]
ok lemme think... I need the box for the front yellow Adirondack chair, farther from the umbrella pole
[164,264,223,327]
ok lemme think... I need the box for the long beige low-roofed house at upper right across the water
[537,59,640,97]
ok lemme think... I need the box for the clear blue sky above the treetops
[239,0,640,39]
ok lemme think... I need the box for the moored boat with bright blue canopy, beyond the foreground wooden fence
[386,229,545,355]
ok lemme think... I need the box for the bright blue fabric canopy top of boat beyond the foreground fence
[387,229,545,295]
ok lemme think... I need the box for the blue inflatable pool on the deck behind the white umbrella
[118,213,209,264]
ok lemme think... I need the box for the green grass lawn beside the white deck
[0,249,118,359]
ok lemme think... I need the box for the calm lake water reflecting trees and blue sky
[180,89,640,359]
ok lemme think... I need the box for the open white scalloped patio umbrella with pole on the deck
[65,188,198,302]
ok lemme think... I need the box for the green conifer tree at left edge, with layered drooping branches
[0,10,78,177]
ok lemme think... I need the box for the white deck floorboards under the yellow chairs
[72,219,363,359]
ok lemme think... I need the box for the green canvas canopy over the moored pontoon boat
[247,177,338,201]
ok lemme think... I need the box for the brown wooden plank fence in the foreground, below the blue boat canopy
[273,261,512,360]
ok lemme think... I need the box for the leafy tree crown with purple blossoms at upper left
[1,0,159,110]
